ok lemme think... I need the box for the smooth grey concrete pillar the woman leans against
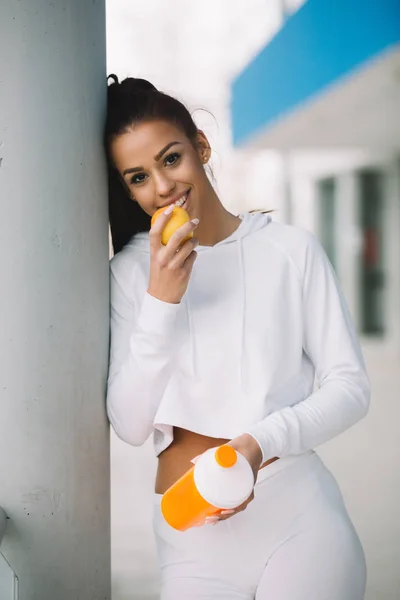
[0,0,110,600]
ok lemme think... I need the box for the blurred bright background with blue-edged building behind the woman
[107,0,400,600]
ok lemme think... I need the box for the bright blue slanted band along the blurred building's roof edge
[232,0,400,144]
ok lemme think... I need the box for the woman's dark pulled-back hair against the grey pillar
[104,75,198,254]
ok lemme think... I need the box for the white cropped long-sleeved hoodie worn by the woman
[107,214,370,460]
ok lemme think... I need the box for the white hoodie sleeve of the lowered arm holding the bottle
[247,234,370,461]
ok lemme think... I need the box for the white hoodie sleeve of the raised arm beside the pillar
[107,262,180,446]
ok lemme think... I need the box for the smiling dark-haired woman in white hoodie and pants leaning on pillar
[105,76,369,600]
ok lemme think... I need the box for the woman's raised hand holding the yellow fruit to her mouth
[147,207,199,304]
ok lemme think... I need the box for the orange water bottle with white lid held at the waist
[161,445,254,531]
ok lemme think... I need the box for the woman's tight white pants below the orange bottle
[154,452,366,600]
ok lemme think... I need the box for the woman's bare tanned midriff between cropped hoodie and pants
[155,427,277,494]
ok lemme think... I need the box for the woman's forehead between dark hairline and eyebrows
[111,121,188,170]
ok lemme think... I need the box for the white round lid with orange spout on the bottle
[194,445,254,509]
